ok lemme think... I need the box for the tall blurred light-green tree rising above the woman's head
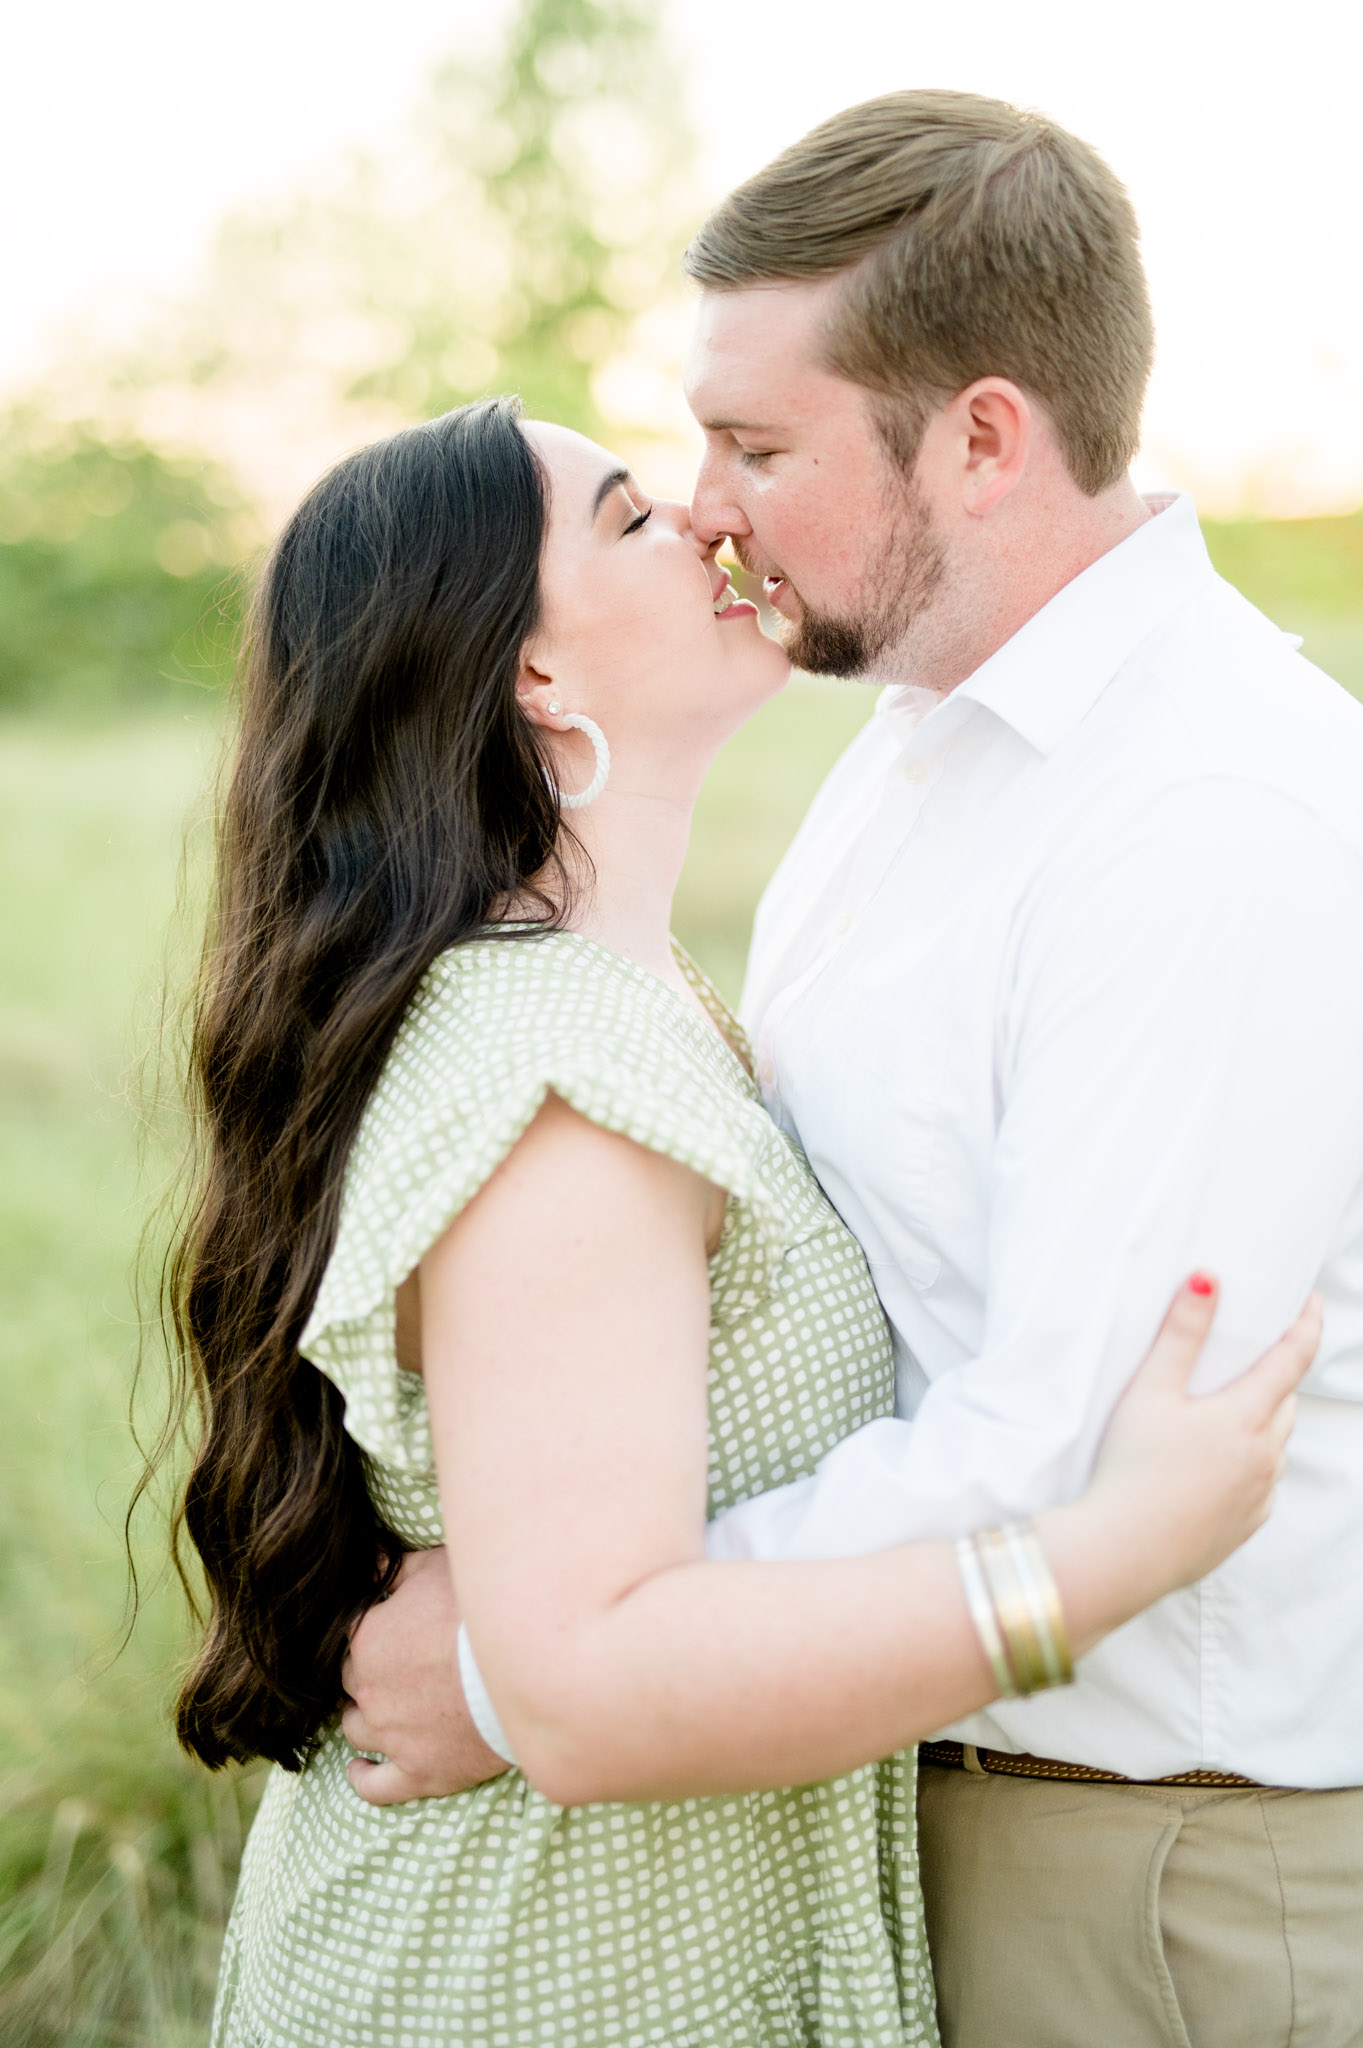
[352,0,694,432]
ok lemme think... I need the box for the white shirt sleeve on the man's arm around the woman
[708,780,1363,1559]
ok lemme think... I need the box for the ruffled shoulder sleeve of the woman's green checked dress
[299,932,821,1475]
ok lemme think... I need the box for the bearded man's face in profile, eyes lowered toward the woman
[686,279,943,676]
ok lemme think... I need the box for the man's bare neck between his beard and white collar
[886,477,1152,696]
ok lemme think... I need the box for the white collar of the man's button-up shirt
[878,492,1216,754]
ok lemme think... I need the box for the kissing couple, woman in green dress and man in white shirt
[176,92,1363,2048]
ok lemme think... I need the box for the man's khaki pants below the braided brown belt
[919,1763,1363,2048]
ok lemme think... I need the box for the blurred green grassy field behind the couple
[0,569,1363,2048]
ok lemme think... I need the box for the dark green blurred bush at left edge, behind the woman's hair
[0,412,258,711]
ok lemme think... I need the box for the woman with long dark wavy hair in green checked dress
[176,403,1316,2048]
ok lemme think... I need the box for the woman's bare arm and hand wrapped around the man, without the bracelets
[422,1102,1310,1804]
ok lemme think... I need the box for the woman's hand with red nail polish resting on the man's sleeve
[1038,1274,1322,1634]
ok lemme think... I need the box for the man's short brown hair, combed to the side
[686,92,1154,494]
